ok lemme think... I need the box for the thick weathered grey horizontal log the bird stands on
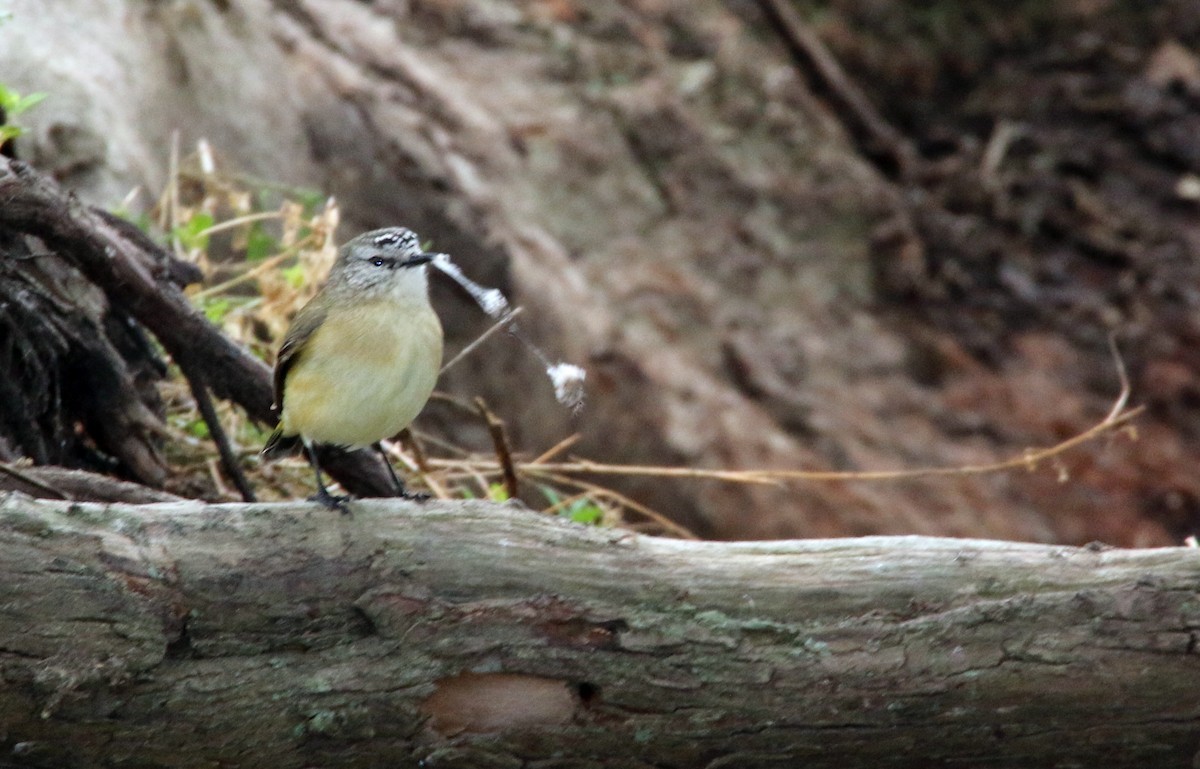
[0,494,1200,769]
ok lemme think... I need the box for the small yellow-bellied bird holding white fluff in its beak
[263,227,442,510]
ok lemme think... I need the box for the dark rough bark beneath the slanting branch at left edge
[0,213,167,485]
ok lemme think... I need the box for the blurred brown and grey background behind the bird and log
[0,0,1200,546]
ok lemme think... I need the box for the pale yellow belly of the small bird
[282,301,442,446]
